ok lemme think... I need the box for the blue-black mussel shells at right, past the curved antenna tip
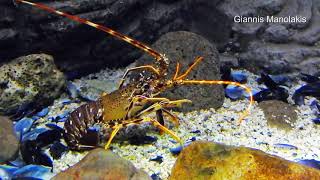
[222,70,320,124]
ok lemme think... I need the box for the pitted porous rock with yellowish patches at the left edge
[0,54,65,114]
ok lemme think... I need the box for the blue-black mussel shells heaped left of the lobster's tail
[0,99,71,179]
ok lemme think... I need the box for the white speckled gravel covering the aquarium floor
[48,68,320,179]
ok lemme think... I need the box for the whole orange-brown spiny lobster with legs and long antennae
[16,0,253,150]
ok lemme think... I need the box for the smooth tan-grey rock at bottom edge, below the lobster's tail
[53,149,151,180]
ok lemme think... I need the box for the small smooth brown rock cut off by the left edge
[0,116,19,163]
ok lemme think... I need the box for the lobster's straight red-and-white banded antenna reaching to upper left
[15,0,166,63]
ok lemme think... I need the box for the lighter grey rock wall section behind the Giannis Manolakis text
[220,0,320,74]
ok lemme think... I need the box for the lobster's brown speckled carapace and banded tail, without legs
[64,83,160,150]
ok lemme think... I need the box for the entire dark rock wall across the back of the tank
[0,0,320,77]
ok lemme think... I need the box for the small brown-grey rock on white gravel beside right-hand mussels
[259,100,298,130]
